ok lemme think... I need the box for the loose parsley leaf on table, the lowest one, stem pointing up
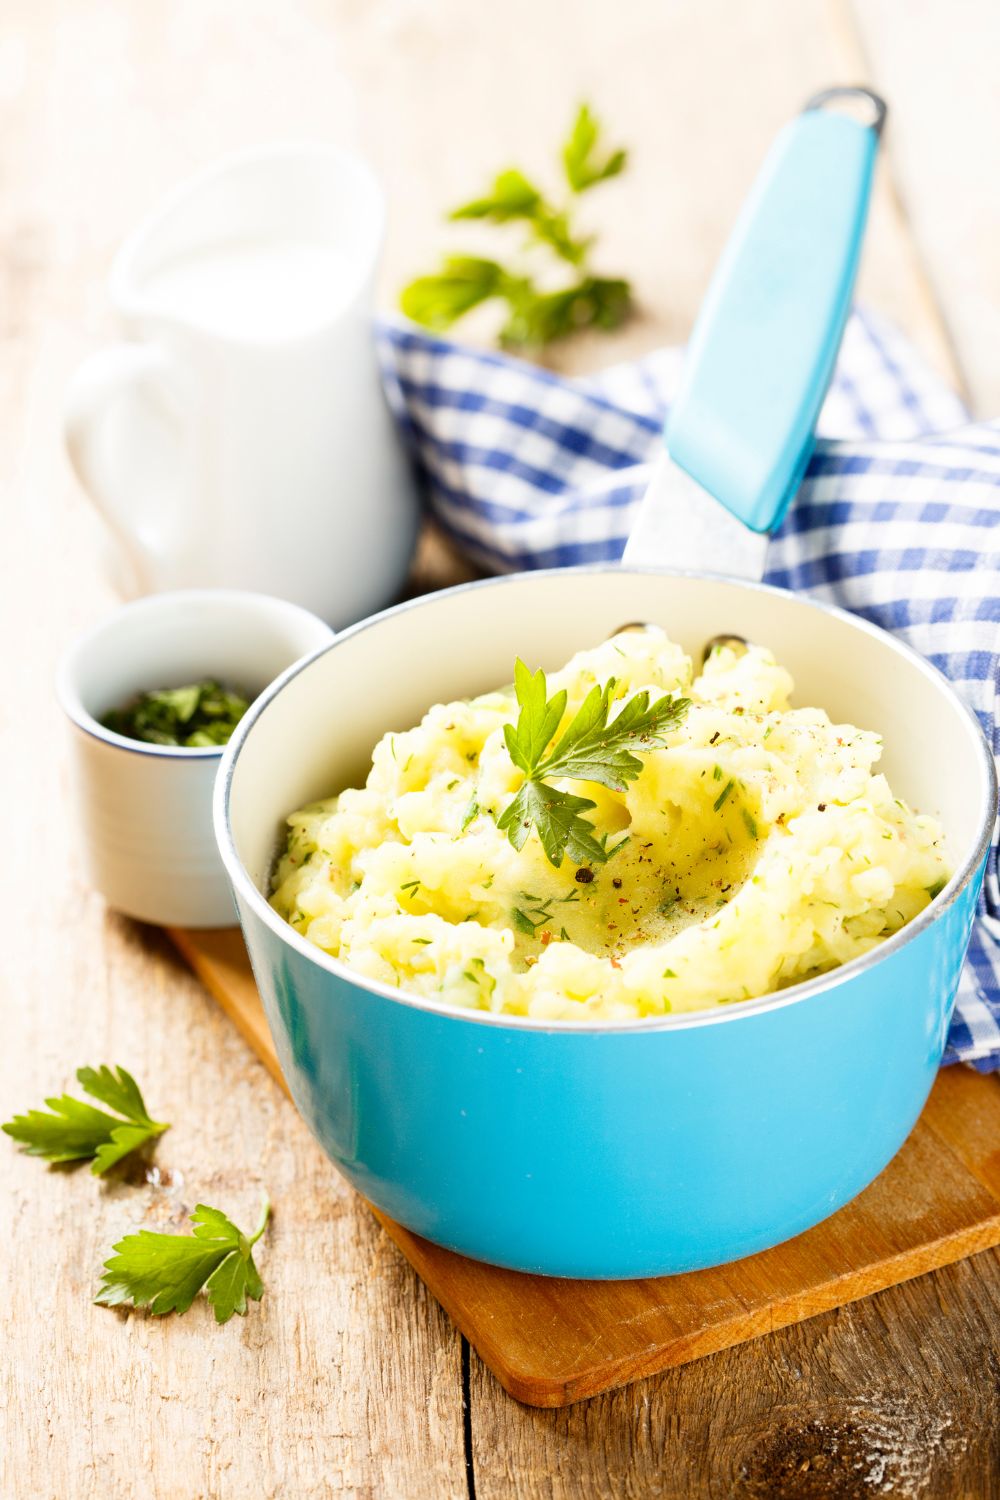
[94,1197,271,1323]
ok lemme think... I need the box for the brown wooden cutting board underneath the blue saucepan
[171,930,1000,1407]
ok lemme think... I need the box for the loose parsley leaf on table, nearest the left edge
[3,1067,169,1178]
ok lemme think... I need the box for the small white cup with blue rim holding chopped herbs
[57,588,333,927]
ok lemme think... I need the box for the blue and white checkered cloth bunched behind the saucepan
[379,311,1000,1073]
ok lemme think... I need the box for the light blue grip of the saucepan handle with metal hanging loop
[664,89,886,531]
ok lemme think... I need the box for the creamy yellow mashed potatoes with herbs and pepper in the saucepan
[271,629,949,1020]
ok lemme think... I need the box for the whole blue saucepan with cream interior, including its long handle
[216,92,996,1277]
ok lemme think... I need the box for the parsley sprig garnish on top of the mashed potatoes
[496,657,691,867]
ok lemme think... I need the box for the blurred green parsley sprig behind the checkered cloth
[400,104,631,348]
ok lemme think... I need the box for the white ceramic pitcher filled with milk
[66,146,418,626]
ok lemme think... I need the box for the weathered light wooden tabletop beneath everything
[0,0,1000,1500]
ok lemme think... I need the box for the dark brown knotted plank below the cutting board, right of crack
[471,1253,1000,1500]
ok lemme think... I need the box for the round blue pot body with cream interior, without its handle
[216,567,996,1277]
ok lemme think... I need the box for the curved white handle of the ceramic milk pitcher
[63,344,190,572]
